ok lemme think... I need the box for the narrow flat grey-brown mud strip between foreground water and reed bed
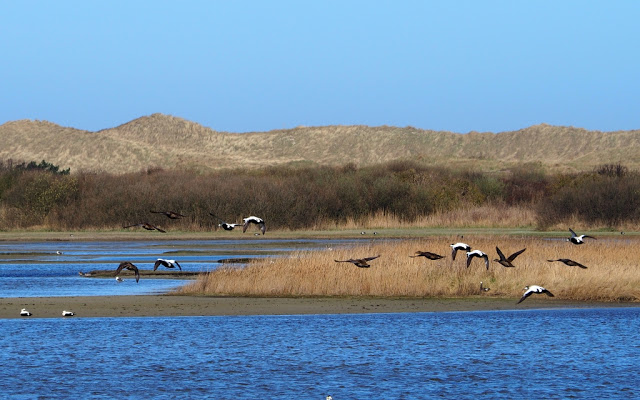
[0,295,640,318]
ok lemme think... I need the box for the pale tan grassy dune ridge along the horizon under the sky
[0,114,640,173]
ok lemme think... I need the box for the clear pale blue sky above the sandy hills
[0,0,640,133]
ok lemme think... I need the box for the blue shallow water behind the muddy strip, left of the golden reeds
[0,239,356,297]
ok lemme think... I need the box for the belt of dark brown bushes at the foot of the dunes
[0,161,640,231]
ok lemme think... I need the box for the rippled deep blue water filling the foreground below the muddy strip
[0,308,640,400]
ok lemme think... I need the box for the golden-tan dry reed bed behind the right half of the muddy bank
[179,236,640,302]
